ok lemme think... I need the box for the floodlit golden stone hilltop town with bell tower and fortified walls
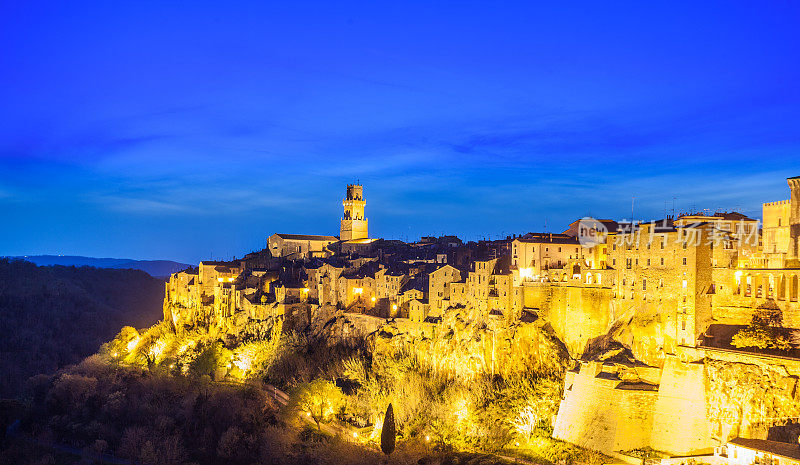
[158,177,800,463]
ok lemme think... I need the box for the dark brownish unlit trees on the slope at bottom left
[0,356,418,465]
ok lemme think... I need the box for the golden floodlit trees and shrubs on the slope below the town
[76,318,602,463]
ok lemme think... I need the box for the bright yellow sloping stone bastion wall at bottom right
[553,349,800,455]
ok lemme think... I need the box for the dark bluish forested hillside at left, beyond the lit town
[0,259,164,397]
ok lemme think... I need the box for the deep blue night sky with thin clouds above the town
[0,0,800,262]
